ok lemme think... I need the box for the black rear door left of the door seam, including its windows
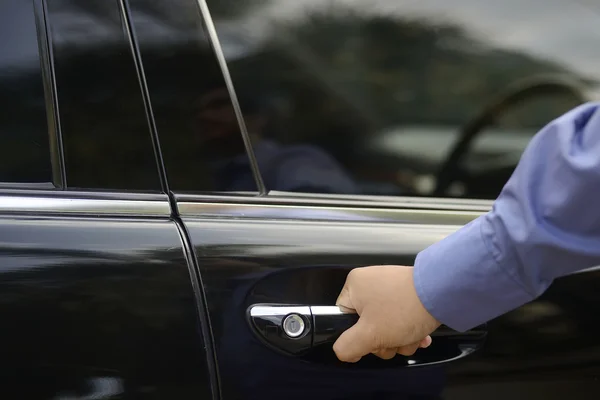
[0,0,213,400]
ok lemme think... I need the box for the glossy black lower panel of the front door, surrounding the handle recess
[182,197,600,400]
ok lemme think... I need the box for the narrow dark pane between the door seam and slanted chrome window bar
[129,0,257,193]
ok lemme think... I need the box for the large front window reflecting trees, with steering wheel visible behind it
[208,0,600,199]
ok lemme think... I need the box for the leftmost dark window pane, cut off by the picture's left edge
[0,0,53,187]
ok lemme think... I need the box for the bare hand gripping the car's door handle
[333,265,441,362]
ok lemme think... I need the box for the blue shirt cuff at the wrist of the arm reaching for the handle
[414,215,534,332]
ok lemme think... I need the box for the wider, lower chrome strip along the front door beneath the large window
[178,202,482,225]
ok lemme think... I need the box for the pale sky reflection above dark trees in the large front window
[219,0,600,90]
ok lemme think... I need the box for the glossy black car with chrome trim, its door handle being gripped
[0,0,600,400]
